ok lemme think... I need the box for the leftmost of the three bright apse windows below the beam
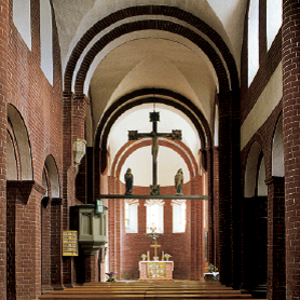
[124,199,139,233]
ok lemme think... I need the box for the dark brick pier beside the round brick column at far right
[266,177,285,300]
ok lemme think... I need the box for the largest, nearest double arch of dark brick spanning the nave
[64,5,239,94]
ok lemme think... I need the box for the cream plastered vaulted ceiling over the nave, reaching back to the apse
[53,0,247,185]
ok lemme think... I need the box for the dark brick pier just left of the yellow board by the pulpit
[51,198,64,290]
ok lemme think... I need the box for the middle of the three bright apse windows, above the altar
[145,200,165,233]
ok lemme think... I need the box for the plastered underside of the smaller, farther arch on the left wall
[42,155,60,198]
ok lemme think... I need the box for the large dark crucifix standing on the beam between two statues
[128,110,181,195]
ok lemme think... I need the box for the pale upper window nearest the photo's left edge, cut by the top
[13,0,31,50]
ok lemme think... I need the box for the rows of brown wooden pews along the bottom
[39,281,266,300]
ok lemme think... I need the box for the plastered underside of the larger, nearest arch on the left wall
[7,104,33,180]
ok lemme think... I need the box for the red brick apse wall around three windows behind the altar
[108,177,204,279]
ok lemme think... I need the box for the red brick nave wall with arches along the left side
[4,0,63,299]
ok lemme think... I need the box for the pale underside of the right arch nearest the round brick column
[272,115,284,177]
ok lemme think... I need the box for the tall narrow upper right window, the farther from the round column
[248,0,259,86]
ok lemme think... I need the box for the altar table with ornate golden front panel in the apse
[139,261,174,281]
